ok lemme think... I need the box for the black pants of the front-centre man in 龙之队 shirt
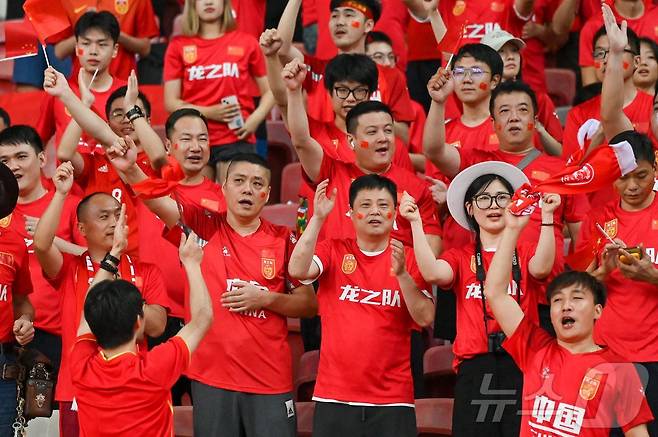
[313,402,417,437]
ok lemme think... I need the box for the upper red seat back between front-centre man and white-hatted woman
[423,344,456,398]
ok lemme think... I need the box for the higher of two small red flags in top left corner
[23,0,73,44]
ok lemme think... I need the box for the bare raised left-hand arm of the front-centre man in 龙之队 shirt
[288,179,336,281]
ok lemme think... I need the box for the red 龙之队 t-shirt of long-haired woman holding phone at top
[163,30,267,146]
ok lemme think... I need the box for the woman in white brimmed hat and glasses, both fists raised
[400,161,560,437]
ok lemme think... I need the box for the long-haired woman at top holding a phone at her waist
[164,0,274,182]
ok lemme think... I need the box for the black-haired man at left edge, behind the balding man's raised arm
[0,125,84,378]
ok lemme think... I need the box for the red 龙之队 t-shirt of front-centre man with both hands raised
[313,238,432,406]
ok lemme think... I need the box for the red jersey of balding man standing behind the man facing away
[48,254,169,401]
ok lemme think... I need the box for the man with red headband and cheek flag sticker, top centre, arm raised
[278,0,414,143]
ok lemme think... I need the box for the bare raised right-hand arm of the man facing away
[177,232,213,353]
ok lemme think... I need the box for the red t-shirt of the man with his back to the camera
[71,334,190,437]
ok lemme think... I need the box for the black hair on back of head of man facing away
[84,279,144,349]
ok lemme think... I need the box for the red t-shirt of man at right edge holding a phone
[578,197,658,362]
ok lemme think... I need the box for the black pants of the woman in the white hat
[452,353,523,437]
